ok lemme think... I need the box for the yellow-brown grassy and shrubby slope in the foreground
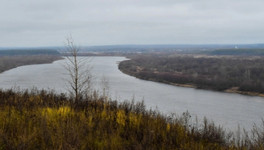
[0,90,264,150]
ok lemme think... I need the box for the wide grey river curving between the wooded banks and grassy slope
[0,57,264,131]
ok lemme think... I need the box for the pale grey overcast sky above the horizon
[0,0,264,47]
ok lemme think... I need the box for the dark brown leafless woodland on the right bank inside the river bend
[119,55,264,93]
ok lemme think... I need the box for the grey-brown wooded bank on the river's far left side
[0,55,61,73]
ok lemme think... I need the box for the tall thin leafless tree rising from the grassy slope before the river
[64,37,92,102]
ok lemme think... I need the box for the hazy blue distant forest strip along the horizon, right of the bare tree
[76,44,264,53]
